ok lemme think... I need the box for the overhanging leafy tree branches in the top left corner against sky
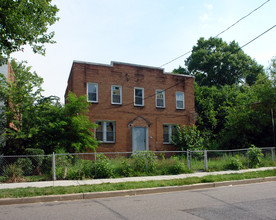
[0,0,59,61]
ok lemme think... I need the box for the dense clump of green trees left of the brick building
[0,61,97,154]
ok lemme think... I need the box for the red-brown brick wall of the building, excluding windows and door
[65,62,195,152]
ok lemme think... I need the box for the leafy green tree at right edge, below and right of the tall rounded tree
[219,58,276,149]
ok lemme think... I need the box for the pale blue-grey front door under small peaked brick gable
[132,127,148,152]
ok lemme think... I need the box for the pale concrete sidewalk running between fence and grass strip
[0,167,276,189]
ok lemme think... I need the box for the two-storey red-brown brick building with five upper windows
[65,61,195,152]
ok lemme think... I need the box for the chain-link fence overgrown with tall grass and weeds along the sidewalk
[0,147,276,182]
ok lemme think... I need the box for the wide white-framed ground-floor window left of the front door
[95,121,115,143]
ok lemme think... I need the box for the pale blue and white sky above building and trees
[11,0,276,103]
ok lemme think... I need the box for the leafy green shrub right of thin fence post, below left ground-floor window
[95,154,114,178]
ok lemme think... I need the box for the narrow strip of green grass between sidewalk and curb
[0,169,276,198]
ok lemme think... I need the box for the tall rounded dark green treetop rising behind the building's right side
[184,37,264,87]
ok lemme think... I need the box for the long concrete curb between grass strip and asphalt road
[0,177,276,205]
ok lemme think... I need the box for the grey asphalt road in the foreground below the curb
[0,182,276,220]
